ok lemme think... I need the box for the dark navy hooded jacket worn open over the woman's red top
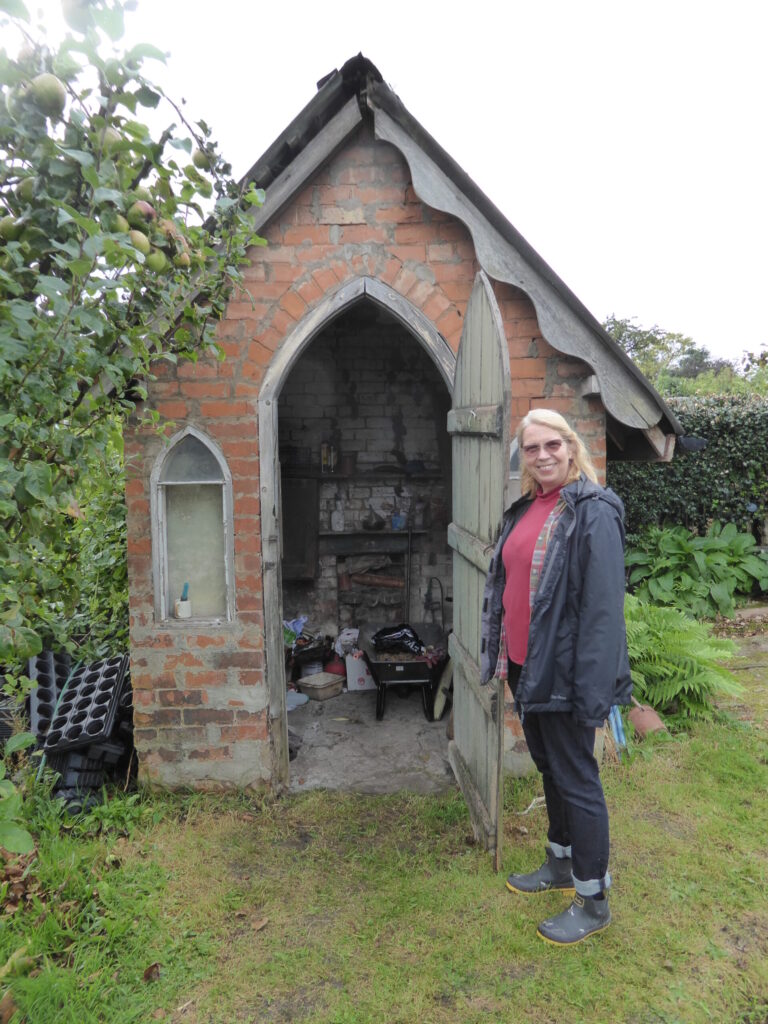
[480,475,632,727]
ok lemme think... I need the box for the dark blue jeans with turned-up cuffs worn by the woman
[509,662,610,896]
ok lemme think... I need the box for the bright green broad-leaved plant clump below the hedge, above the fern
[627,522,768,618]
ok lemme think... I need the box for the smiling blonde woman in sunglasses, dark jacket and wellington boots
[481,409,632,945]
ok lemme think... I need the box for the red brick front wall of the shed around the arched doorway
[126,121,605,785]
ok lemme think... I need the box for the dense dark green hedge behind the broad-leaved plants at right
[607,395,768,539]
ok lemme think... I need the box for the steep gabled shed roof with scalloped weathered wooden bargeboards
[245,54,683,459]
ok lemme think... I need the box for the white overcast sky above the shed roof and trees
[27,0,768,358]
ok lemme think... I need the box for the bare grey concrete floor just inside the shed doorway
[288,686,456,794]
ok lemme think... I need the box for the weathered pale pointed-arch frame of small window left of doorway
[150,426,234,627]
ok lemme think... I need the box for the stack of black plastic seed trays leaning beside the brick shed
[29,651,133,814]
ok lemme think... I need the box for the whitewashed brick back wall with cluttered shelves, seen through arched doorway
[279,300,452,635]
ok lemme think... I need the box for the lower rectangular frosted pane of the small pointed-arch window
[165,483,226,618]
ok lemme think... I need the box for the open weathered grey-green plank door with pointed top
[447,271,510,870]
